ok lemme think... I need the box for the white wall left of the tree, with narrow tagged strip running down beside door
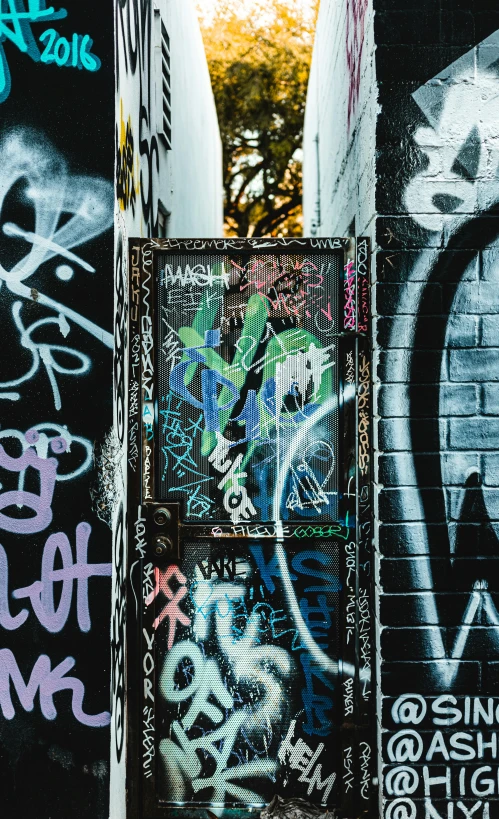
[110,0,223,819]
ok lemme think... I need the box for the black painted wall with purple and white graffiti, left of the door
[0,0,114,819]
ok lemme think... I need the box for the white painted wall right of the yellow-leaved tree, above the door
[303,0,377,236]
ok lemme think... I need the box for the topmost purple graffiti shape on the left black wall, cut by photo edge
[0,445,57,535]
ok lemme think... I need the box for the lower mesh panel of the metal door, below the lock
[155,541,340,806]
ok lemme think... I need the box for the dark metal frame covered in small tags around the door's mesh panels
[126,238,376,819]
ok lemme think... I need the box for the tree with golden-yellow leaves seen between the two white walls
[202,0,318,236]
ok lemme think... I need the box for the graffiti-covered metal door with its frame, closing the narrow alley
[128,239,372,819]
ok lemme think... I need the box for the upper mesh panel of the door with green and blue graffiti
[156,253,342,522]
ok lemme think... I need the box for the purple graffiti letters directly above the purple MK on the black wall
[7,523,111,634]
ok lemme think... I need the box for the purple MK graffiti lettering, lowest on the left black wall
[0,648,111,728]
